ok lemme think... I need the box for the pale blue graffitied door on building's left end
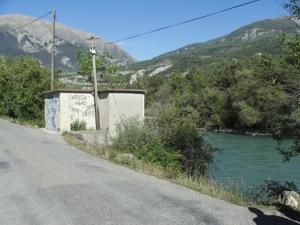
[45,95,59,130]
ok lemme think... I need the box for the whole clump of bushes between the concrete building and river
[112,107,219,179]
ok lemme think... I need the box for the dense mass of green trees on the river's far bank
[133,54,300,132]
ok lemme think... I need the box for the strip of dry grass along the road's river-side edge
[63,132,275,209]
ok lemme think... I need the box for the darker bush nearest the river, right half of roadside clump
[157,106,220,179]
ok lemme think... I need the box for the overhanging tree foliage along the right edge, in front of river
[273,0,300,162]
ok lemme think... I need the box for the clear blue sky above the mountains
[0,0,287,60]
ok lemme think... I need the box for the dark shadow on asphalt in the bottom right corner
[248,207,300,225]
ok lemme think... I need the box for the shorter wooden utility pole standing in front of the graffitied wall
[90,36,100,130]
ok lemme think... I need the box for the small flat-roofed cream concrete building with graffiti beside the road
[43,89,146,140]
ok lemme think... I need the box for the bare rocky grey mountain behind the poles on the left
[0,15,137,71]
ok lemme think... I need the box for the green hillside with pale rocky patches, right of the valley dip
[122,17,298,80]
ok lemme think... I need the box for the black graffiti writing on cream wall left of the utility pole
[68,94,95,121]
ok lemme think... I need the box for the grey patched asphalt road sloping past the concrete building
[0,120,299,225]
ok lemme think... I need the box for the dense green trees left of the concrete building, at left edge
[0,57,63,120]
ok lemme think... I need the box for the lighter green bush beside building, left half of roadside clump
[112,117,182,177]
